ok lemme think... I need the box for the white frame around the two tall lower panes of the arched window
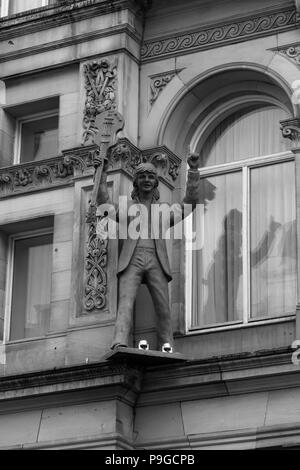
[185,151,298,334]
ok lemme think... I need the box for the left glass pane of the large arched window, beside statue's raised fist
[192,172,243,326]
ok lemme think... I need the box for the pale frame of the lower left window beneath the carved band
[3,227,54,344]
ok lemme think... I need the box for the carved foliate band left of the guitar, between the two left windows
[0,145,97,198]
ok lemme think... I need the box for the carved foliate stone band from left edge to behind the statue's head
[0,138,181,199]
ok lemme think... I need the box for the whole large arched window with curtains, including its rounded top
[186,102,296,329]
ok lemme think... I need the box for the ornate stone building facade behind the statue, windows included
[0,0,300,450]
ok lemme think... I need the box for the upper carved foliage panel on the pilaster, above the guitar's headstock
[82,59,117,145]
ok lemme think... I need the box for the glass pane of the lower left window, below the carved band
[10,235,52,340]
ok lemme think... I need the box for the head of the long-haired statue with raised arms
[131,162,159,200]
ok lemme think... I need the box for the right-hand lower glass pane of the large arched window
[250,162,296,318]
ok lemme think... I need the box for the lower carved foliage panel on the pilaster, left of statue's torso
[83,205,107,313]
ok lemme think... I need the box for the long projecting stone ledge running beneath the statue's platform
[0,349,300,406]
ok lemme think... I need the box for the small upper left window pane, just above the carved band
[20,116,58,163]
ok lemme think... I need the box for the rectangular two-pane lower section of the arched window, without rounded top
[186,154,297,329]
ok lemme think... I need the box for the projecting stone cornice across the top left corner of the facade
[0,0,147,41]
